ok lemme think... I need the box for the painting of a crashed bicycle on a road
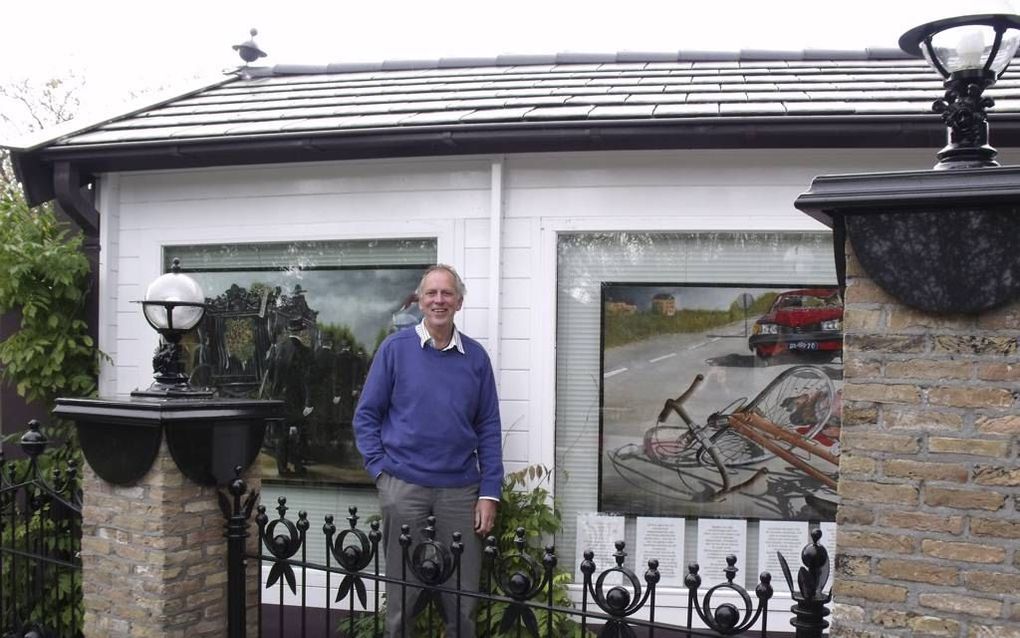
[599,283,843,521]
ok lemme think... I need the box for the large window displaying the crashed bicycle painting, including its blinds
[556,233,843,582]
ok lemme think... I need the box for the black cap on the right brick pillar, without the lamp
[794,166,1020,313]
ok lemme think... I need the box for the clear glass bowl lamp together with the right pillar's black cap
[795,14,1020,313]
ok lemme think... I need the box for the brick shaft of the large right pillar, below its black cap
[831,244,1020,638]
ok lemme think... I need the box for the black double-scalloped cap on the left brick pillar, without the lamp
[53,396,284,485]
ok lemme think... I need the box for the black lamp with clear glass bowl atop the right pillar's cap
[900,13,1020,169]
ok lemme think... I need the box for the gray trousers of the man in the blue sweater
[375,473,481,638]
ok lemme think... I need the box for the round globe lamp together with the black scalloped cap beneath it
[53,259,283,485]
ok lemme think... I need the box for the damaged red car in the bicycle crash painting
[748,288,843,359]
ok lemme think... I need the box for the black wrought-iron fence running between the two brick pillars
[220,469,831,638]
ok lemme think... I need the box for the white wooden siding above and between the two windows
[99,149,931,470]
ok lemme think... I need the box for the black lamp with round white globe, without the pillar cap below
[132,259,212,397]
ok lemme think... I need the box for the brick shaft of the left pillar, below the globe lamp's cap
[82,441,260,638]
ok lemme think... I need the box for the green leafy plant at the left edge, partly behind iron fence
[0,184,92,636]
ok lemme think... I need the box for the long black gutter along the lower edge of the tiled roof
[11,114,1020,204]
